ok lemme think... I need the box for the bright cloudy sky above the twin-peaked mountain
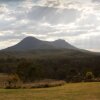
[0,0,100,52]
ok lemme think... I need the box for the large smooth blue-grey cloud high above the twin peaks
[28,6,80,24]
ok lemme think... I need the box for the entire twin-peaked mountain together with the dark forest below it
[0,37,100,82]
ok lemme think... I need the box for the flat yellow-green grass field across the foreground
[0,82,100,100]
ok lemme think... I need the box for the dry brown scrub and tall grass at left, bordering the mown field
[0,74,66,89]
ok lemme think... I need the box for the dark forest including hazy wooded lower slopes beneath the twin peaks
[0,49,100,82]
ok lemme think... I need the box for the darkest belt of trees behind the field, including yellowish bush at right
[0,55,100,82]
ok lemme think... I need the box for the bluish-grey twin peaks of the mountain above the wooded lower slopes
[4,37,76,51]
